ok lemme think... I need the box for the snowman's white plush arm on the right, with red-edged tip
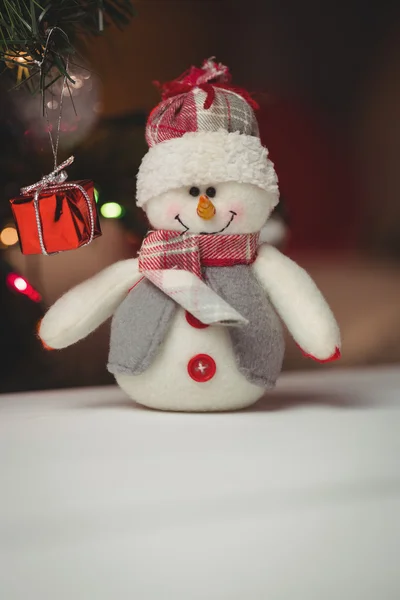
[253,245,341,362]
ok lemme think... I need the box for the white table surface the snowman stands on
[0,369,400,600]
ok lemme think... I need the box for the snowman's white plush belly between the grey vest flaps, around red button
[115,309,265,411]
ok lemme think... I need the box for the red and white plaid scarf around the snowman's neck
[139,230,259,325]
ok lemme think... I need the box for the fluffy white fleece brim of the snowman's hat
[136,129,279,207]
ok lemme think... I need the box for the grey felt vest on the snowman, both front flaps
[108,265,285,388]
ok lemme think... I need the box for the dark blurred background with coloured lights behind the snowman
[0,0,400,391]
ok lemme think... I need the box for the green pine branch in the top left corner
[0,0,134,93]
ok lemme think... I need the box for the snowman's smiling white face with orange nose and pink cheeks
[145,182,277,235]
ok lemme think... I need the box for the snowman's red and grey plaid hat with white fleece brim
[137,59,279,206]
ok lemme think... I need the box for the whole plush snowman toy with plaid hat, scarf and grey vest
[39,60,340,411]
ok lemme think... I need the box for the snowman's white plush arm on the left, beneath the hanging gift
[38,258,141,349]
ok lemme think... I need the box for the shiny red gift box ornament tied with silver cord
[10,156,101,255]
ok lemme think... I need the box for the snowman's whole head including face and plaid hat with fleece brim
[137,60,279,234]
